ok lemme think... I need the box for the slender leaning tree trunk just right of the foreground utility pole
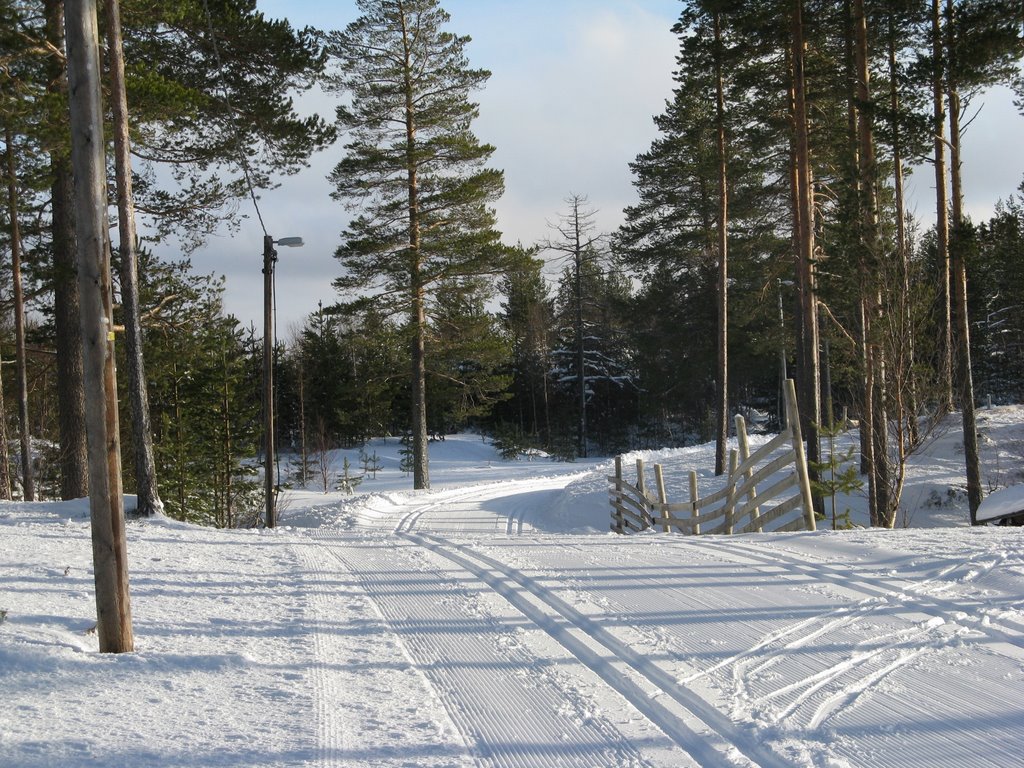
[105,0,164,516]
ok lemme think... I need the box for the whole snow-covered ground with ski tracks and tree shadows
[0,408,1024,768]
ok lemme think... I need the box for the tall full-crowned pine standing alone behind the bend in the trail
[329,0,504,488]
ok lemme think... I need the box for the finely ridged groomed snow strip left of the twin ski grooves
[317,532,679,768]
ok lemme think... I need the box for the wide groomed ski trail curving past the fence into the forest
[290,477,1024,768]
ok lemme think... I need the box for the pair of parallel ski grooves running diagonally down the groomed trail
[402,534,791,768]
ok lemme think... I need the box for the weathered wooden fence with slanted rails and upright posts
[608,379,815,534]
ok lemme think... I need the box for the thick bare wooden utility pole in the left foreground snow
[65,0,134,653]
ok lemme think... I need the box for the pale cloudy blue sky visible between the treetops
[165,0,1024,338]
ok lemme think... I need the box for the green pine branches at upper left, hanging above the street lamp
[121,0,335,244]
